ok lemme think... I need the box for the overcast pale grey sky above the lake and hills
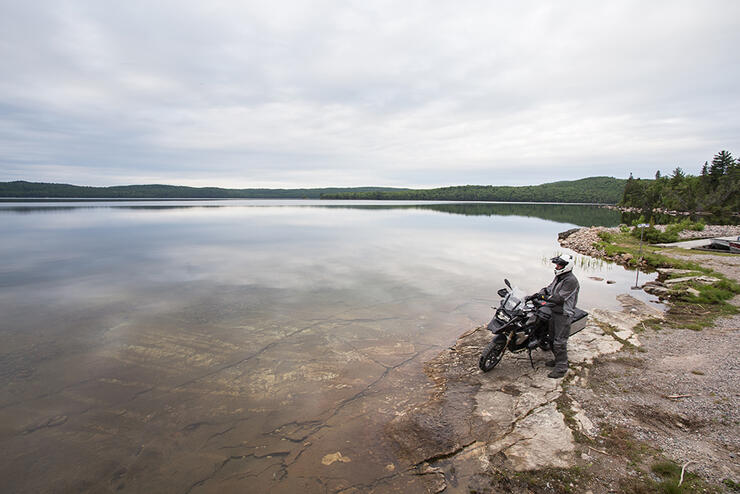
[0,0,740,187]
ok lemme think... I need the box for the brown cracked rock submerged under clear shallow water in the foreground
[0,309,467,494]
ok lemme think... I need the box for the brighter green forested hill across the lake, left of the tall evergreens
[321,177,626,204]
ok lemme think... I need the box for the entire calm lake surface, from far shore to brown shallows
[0,200,649,492]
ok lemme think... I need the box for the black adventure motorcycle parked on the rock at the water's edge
[478,279,588,372]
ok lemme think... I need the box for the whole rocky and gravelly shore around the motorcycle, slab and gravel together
[386,227,740,494]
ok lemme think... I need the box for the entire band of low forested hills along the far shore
[0,177,626,204]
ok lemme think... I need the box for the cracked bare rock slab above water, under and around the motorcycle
[386,295,661,492]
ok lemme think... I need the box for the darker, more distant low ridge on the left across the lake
[0,181,404,199]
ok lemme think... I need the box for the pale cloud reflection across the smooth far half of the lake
[0,201,652,330]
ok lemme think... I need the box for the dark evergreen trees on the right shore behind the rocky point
[620,151,740,216]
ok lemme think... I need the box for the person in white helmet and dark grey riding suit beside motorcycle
[527,254,580,379]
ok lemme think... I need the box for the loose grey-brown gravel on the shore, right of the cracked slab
[561,233,740,483]
